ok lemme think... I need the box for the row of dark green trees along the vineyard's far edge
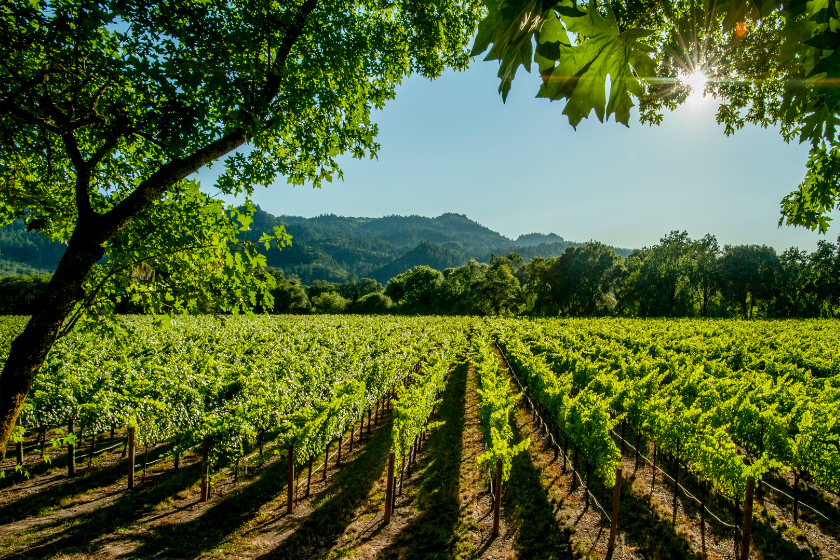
[6,231,840,318]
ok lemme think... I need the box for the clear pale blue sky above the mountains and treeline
[203,60,840,251]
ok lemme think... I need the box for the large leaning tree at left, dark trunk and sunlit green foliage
[0,0,480,453]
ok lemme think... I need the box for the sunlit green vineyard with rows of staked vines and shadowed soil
[0,315,840,558]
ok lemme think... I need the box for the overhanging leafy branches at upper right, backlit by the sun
[471,0,840,233]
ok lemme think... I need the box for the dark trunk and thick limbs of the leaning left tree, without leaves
[0,0,318,460]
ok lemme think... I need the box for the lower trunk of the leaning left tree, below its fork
[0,230,105,459]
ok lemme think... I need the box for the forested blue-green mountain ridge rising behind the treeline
[0,208,630,284]
